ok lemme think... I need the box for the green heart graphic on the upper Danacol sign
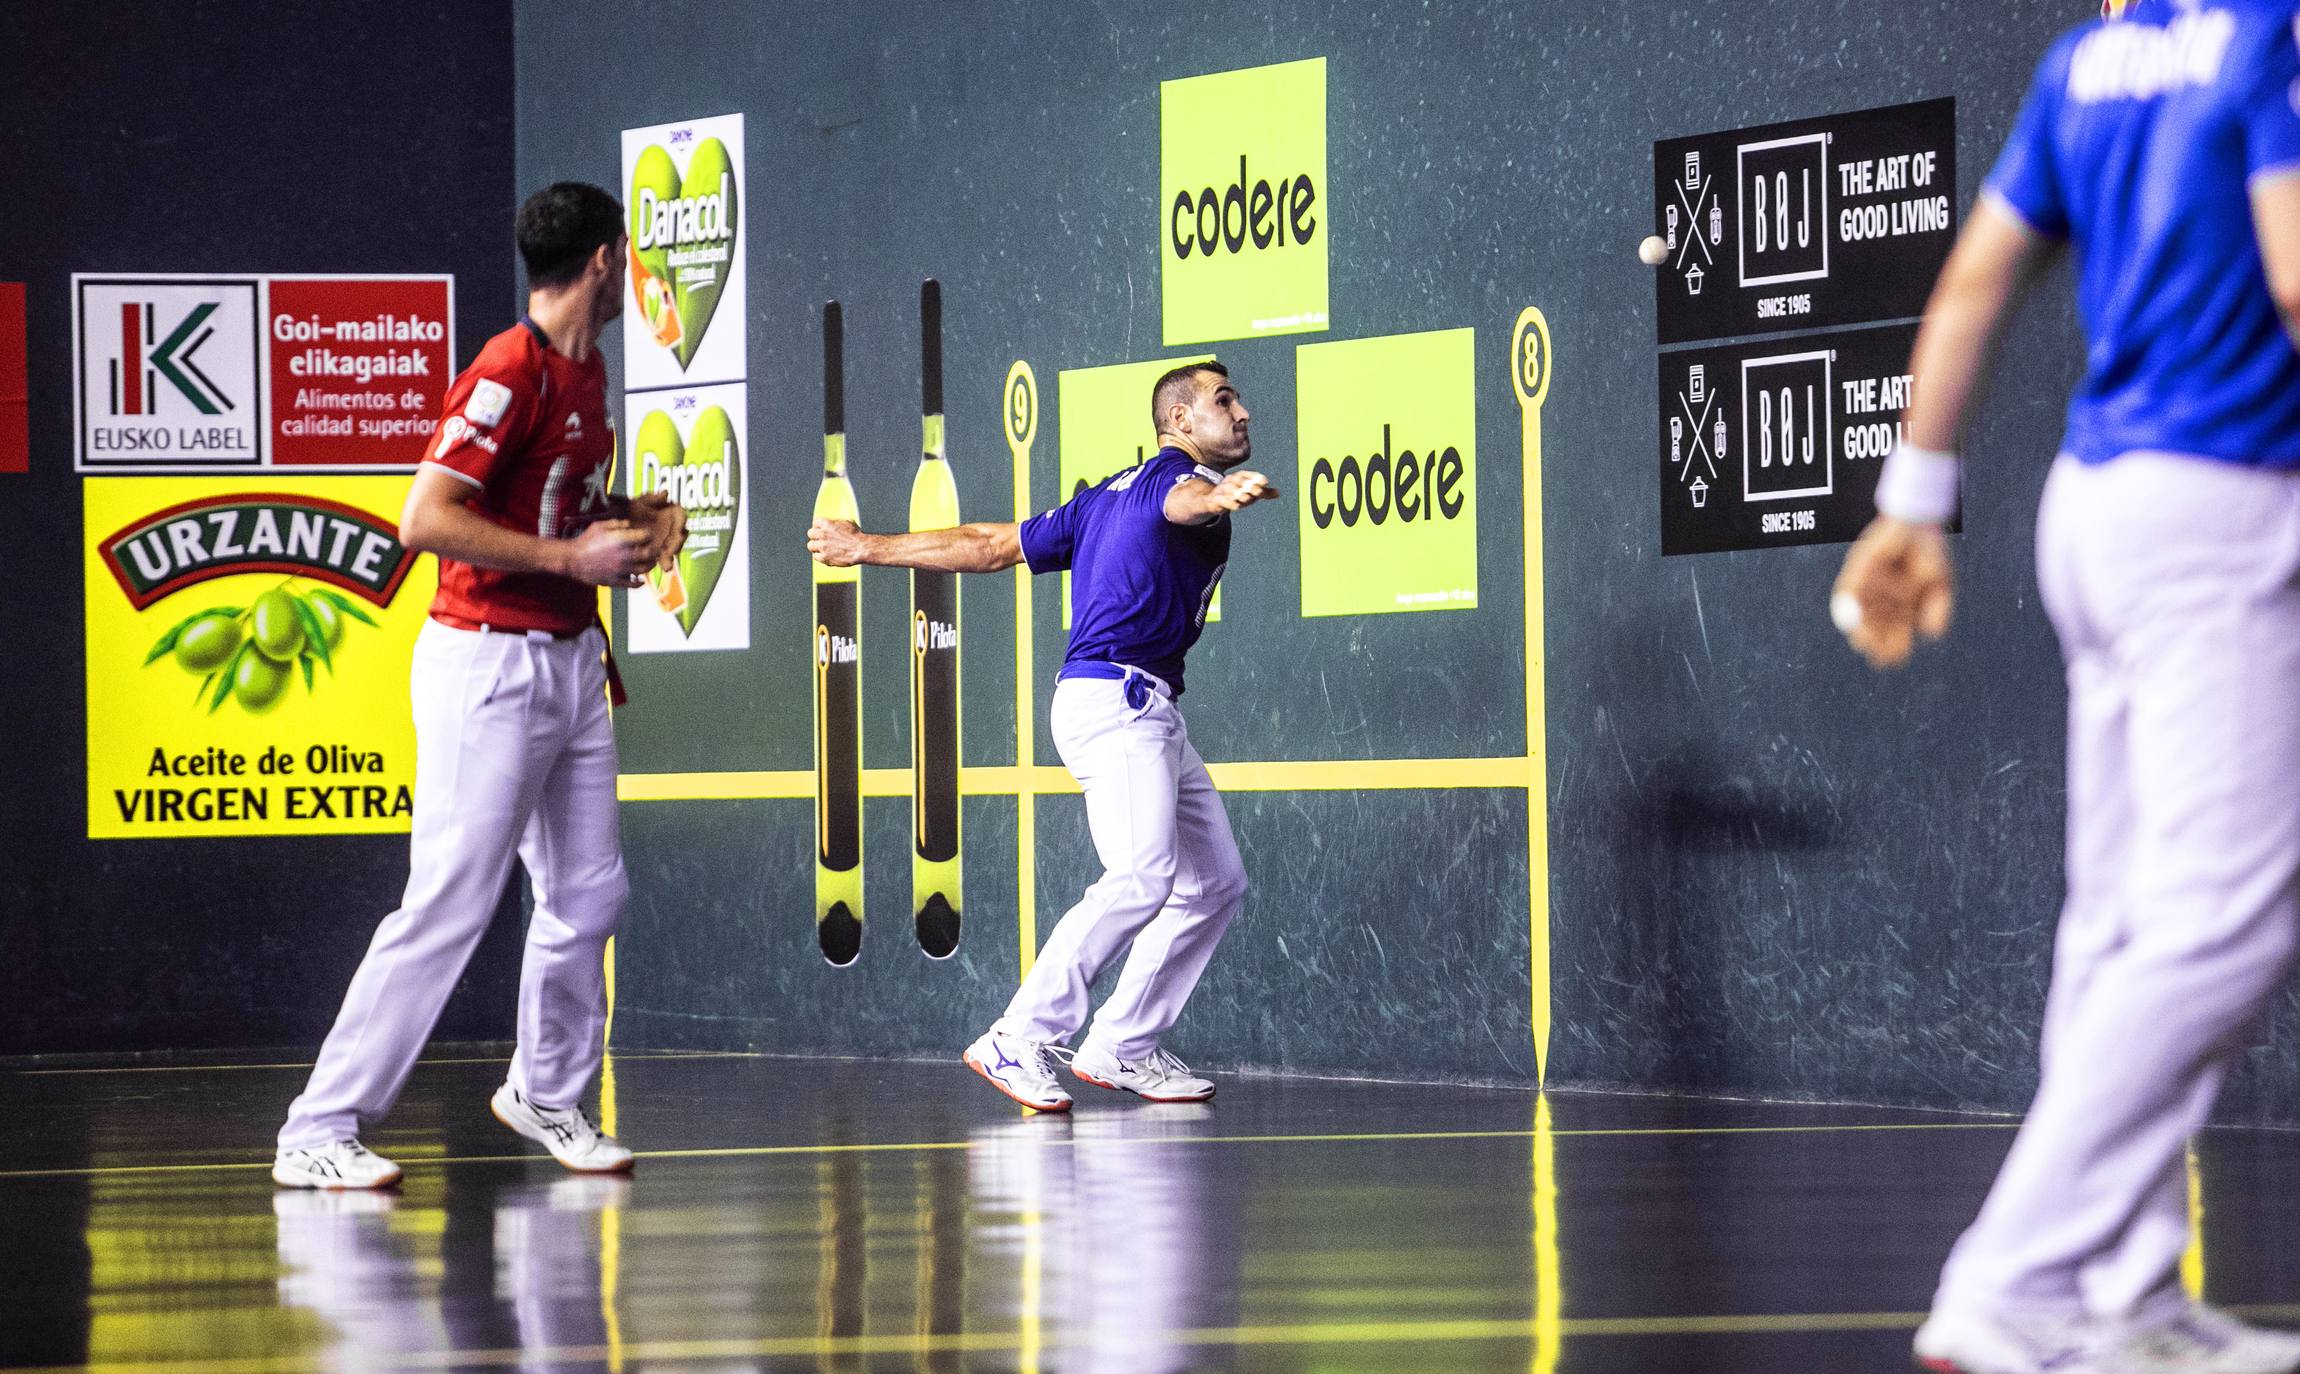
[628,138,741,368]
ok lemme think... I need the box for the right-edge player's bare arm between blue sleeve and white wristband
[1902,196,2052,453]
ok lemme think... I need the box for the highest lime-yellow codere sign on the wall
[1159,58,1332,348]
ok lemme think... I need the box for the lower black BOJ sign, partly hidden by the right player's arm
[1661,325,1968,555]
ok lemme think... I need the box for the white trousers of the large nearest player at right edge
[1937,453,2300,1316]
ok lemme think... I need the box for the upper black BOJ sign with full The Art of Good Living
[1654,99,1957,343]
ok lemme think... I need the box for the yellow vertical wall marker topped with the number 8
[1509,306,1550,1084]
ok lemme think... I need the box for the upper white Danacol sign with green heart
[623,115,745,391]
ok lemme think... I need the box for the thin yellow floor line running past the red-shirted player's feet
[0,1121,2019,1183]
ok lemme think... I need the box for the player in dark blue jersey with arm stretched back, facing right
[807,364,1279,1112]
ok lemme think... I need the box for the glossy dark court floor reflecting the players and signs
[0,1049,2300,1374]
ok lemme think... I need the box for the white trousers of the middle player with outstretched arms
[996,679,1247,1059]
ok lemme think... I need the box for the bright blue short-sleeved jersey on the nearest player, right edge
[1987,0,2300,467]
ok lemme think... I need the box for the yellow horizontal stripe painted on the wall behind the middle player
[614,757,1532,801]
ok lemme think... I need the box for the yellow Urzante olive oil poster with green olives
[85,474,437,840]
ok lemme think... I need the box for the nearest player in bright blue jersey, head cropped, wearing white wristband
[1831,0,2300,1374]
